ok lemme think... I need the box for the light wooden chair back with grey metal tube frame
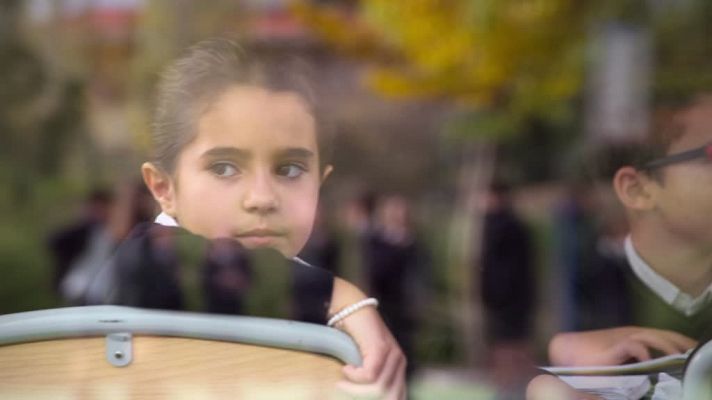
[0,306,361,399]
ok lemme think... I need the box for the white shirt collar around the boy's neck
[625,235,712,316]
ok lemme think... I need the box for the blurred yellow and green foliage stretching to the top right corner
[299,0,712,140]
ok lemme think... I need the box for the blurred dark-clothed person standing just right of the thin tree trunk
[480,182,535,399]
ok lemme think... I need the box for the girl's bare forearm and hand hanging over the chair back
[329,277,406,400]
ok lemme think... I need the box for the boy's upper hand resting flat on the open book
[549,326,697,366]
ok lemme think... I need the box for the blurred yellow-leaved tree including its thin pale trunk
[296,0,590,362]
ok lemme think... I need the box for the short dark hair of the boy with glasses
[587,97,700,180]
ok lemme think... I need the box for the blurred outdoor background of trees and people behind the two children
[0,0,712,399]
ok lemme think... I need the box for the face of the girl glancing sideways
[159,86,329,257]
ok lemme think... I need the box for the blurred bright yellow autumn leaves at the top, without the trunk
[302,0,588,138]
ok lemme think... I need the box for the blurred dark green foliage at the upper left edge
[0,1,95,208]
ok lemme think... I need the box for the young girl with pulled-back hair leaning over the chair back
[118,40,405,399]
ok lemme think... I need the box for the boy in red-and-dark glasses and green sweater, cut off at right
[528,97,712,399]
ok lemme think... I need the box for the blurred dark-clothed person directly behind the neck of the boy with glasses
[553,183,631,331]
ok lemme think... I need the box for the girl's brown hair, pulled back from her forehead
[151,38,331,173]
